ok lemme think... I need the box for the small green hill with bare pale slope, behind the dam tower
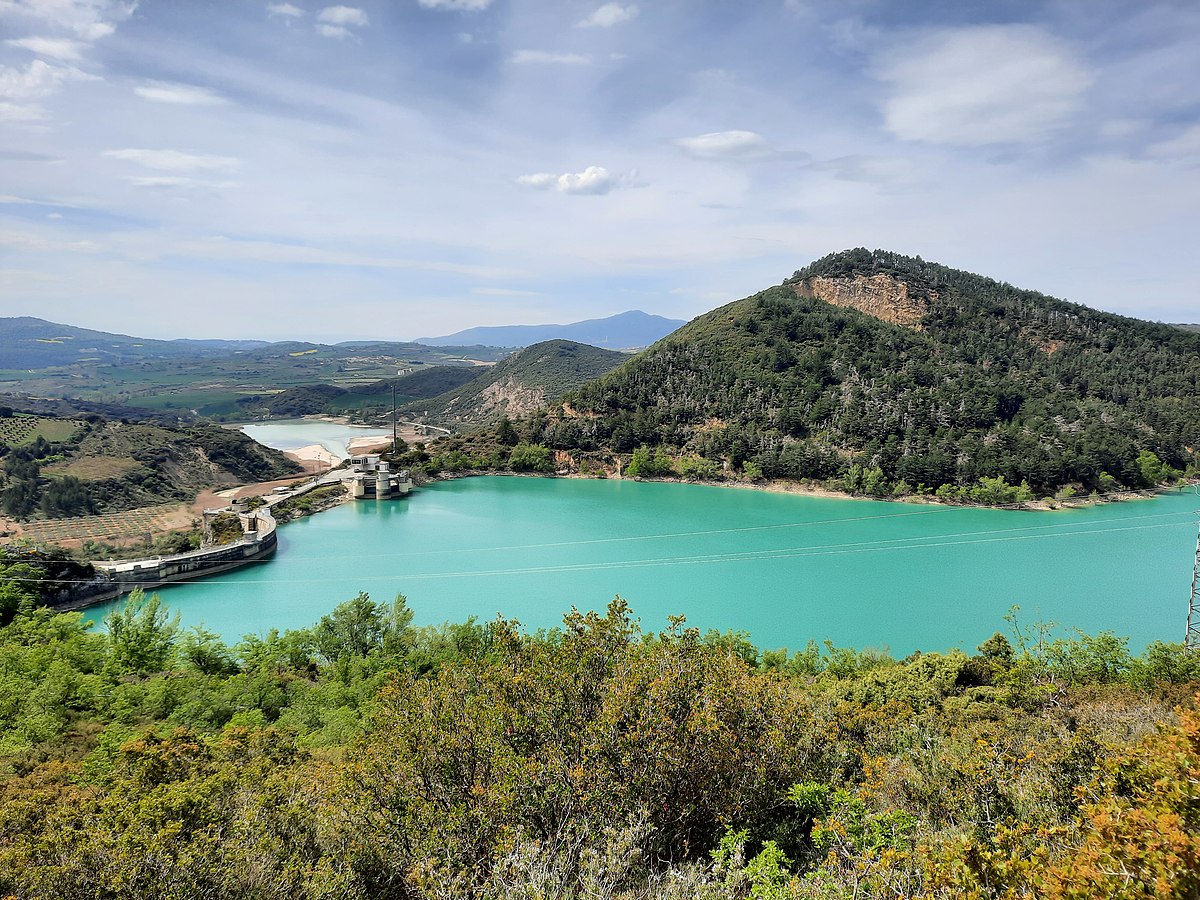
[403,341,629,425]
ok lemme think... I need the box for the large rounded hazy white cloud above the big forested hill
[877,25,1092,146]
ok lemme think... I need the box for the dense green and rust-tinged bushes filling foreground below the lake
[0,594,1200,900]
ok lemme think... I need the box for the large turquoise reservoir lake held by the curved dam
[96,476,1200,655]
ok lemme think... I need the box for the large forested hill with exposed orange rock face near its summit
[547,250,1200,496]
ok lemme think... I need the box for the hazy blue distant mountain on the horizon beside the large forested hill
[416,310,685,350]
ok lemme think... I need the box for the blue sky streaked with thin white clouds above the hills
[0,0,1200,340]
